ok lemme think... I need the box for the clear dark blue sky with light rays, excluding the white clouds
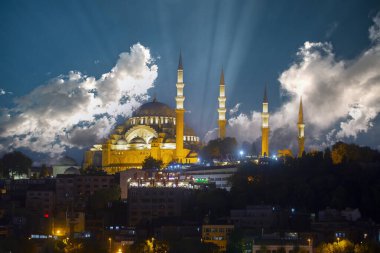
[0,0,380,161]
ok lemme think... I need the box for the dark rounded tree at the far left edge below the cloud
[1,151,32,177]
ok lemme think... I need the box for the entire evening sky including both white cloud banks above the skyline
[0,0,380,161]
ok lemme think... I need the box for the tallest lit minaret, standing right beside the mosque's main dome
[175,53,185,163]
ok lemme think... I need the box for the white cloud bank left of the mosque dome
[0,43,158,156]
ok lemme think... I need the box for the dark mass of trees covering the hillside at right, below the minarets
[231,146,380,221]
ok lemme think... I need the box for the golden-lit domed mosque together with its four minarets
[83,54,305,174]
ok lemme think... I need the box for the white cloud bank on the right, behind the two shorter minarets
[228,14,380,151]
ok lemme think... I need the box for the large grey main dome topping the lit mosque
[132,100,175,117]
